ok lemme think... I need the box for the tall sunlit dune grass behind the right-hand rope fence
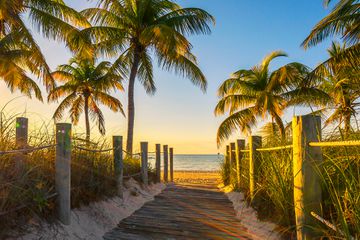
[222,131,360,239]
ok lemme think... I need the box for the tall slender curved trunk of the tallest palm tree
[126,48,140,156]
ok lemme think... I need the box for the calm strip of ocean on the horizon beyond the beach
[149,154,223,171]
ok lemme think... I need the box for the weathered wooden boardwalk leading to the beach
[104,185,252,240]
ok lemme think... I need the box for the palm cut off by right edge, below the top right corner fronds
[316,42,360,136]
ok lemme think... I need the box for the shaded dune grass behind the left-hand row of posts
[0,115,155,238]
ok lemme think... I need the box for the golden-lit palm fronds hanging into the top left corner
[0,0,89,95]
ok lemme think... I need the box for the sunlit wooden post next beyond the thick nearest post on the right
[249,136,262,199]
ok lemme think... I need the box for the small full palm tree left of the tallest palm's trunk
[48,58,124,142]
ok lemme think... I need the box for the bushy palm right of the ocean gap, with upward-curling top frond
[215,51,328,145]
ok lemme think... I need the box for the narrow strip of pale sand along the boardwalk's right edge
[223,189,281,240]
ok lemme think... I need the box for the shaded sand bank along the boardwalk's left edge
[18,179,165,240]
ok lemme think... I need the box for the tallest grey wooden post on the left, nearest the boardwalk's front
[55,123,71,225]
